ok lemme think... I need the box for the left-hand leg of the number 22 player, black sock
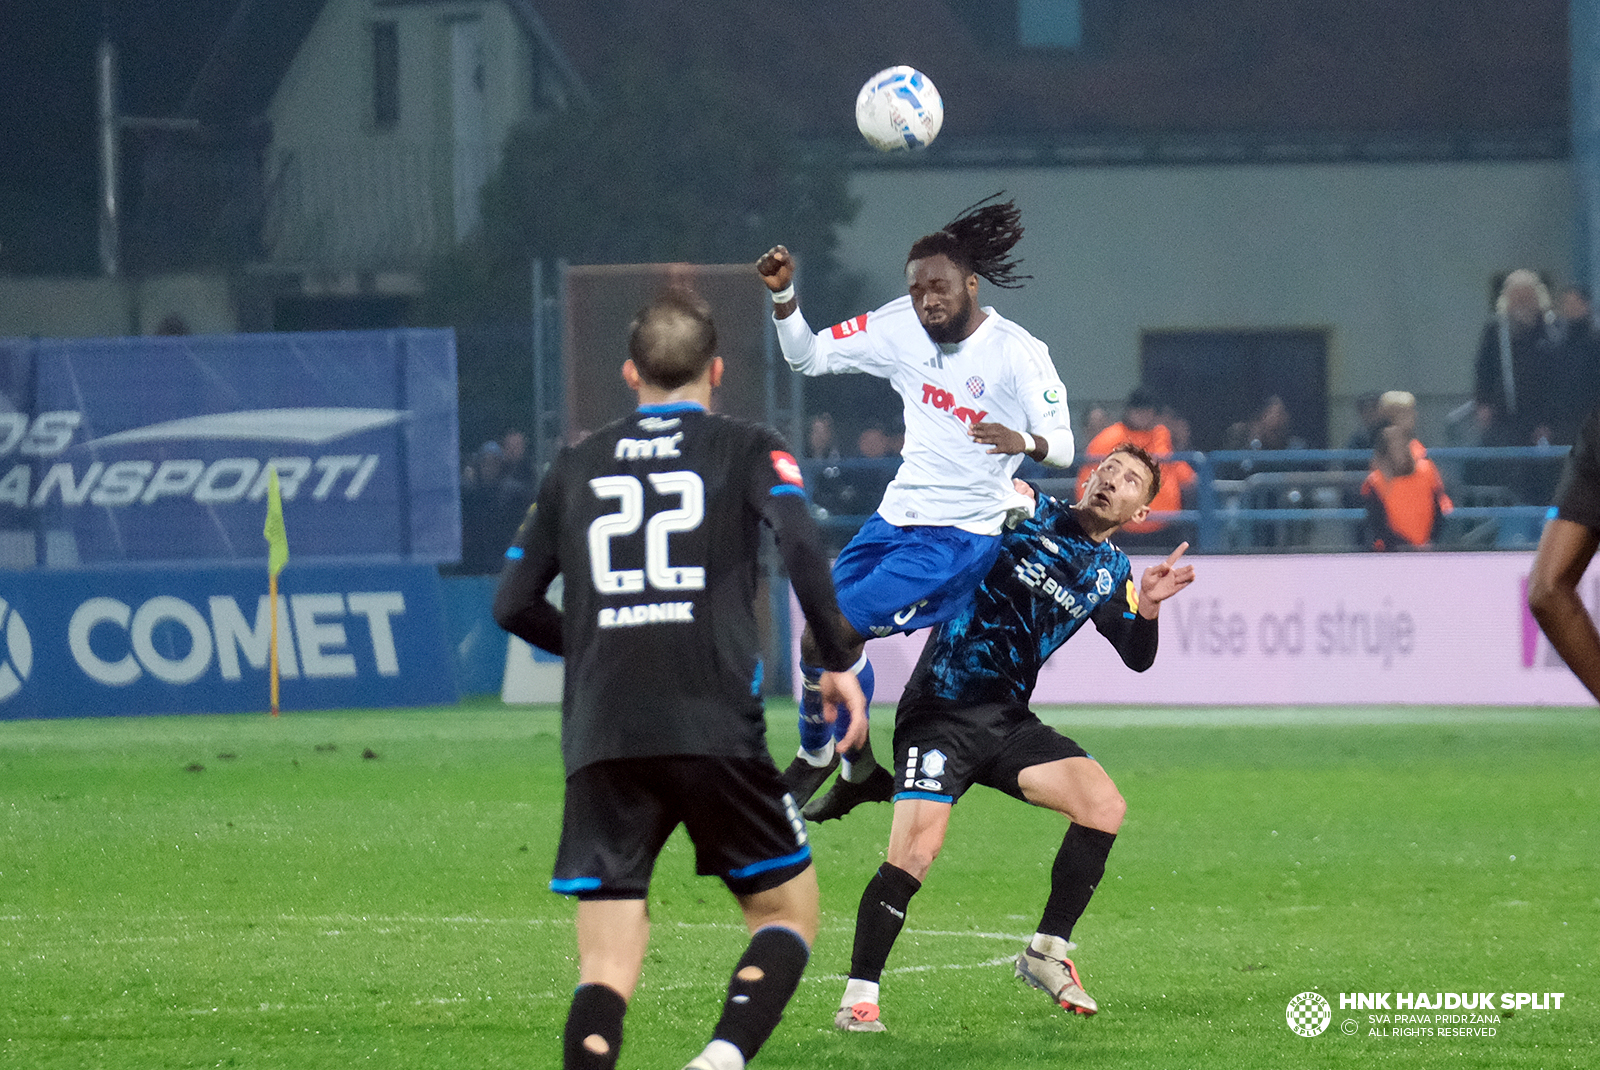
[563,899,650,1070]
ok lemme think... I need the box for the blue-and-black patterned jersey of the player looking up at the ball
[901,494,1154,707]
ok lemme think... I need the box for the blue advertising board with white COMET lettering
[0,565,458,720]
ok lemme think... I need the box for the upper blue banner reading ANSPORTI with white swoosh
[0,329,461,568]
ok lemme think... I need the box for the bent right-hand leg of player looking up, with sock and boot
[1016,758,1128,1014]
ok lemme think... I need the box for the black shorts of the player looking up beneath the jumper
[894,702,1088,803]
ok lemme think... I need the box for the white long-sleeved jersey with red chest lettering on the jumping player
[776,294,1072,534]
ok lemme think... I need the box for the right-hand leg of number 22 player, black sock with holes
[685,867,818,1070]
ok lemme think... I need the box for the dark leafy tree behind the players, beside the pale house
[418,45,858,443]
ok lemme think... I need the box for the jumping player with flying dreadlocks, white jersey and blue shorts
[755,194,1074,820]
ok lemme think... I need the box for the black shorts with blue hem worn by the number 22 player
[550,755,811,899]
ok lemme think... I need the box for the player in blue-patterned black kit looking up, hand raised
[834,443,1194,1032]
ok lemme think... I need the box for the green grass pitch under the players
[0,701,1600,1070]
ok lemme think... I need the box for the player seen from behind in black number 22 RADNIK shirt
[494,291,866,1070]
